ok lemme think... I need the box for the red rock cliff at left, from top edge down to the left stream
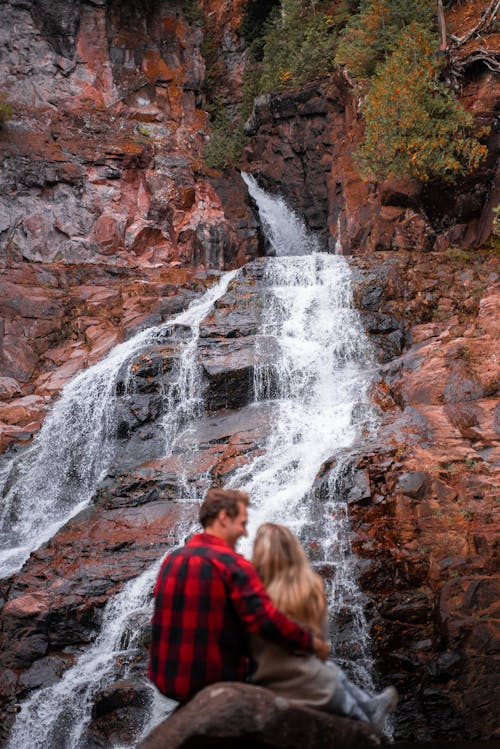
[0,2,258,448]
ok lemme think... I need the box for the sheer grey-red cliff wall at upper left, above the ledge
[1,3,255,267]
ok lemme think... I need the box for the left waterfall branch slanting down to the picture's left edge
[0,271,236,577]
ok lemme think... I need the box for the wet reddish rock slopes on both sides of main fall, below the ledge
[0,253,500,746]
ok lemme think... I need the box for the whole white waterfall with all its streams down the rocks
[4,175,373,749]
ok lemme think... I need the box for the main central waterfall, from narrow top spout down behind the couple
[231,175,373,688]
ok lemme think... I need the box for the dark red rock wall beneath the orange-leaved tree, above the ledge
[244,74,500,255]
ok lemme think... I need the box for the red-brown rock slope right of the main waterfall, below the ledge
[351,248,500,740]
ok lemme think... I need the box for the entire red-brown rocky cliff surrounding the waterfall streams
[0,0,500,746]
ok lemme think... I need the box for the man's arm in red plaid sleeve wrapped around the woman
[228,557,330,660]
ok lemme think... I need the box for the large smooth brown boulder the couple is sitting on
[138,682,379,749]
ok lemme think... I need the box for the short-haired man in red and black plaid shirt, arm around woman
[148,489,329,702]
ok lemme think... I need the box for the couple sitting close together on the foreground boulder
[149,489,396,731]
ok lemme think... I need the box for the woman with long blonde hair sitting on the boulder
[250,523,397,731]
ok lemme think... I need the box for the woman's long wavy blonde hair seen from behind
[252,523,326,636]
